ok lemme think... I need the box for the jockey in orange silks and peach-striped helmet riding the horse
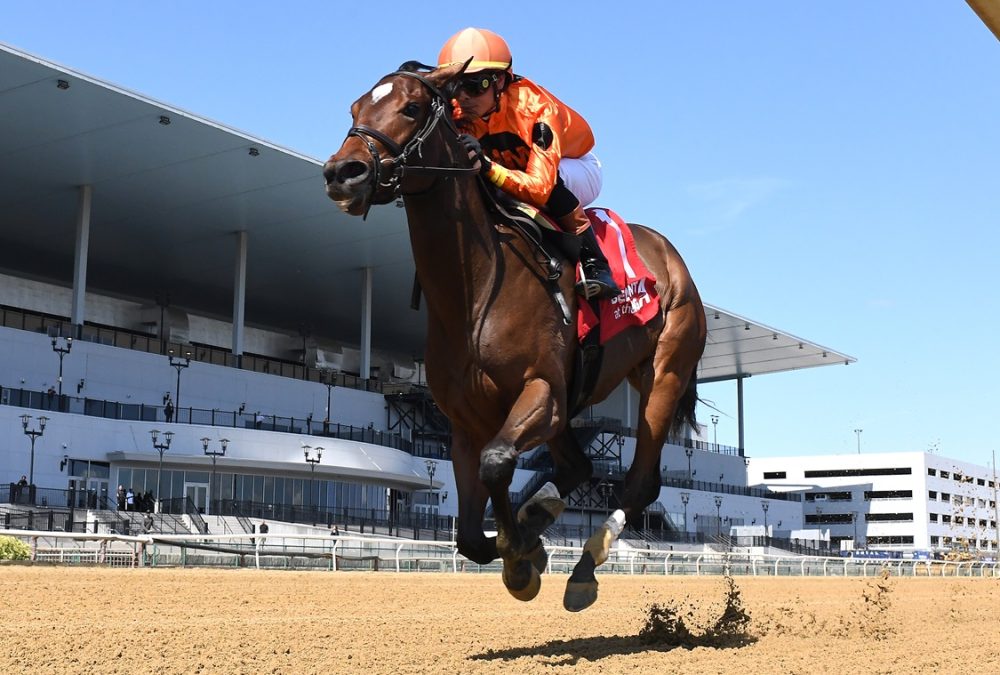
[438,28,619,298]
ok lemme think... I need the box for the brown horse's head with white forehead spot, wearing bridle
[323,64,465,216]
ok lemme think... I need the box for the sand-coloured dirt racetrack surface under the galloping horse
[0,566,1000,675]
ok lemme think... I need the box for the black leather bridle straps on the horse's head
[347,70,479,218]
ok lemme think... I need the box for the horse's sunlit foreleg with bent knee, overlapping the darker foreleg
[479,379,564,600]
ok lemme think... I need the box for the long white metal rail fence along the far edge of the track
[7,530,1000,578]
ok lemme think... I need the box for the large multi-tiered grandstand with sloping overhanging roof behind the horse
[0,39,853,557]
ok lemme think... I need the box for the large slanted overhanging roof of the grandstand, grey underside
[0,43,854,380]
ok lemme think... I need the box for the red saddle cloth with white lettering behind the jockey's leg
[576,208,659,344]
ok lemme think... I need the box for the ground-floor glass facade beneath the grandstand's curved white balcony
[116,467,389,510]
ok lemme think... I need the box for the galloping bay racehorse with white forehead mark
[323,62,706,611]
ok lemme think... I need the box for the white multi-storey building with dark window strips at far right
[748,452,998,552]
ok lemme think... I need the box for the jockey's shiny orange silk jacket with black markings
[483,79,594,208]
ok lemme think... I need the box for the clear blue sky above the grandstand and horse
[0,0,1000,465]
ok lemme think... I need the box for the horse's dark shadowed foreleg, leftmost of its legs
[451,427,500,565]
